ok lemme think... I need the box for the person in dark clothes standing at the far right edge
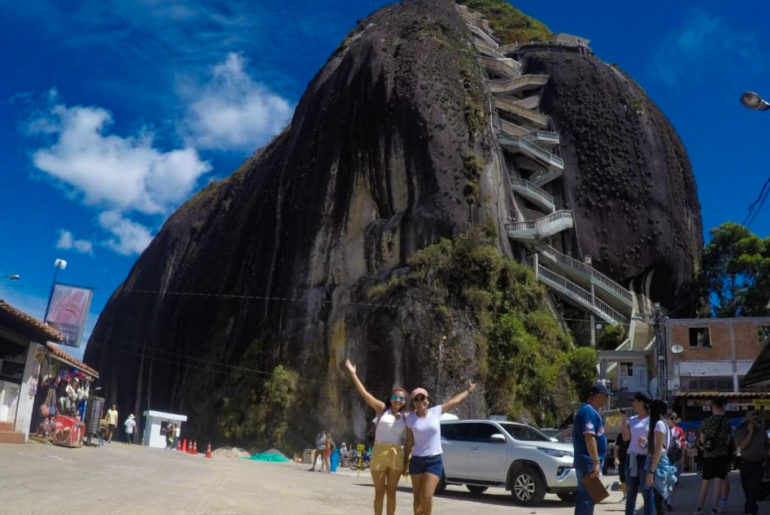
[735,411,770,515]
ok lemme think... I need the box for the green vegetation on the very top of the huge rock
[457,0,553,44]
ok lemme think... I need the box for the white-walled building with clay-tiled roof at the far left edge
[0,300,63,443]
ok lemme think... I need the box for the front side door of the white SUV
[468,422,508,483]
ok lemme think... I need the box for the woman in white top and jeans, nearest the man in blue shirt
[623,392,653,515]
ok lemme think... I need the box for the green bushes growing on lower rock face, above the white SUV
[369,227,580,424]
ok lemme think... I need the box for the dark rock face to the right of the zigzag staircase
[520,51,703,310]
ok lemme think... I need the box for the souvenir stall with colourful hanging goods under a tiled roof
[33,343,99,447]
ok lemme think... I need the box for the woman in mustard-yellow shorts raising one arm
[345,359,406,515]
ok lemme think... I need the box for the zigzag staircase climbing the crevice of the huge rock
[457,5,648,334]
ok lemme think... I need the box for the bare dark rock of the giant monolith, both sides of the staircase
[85,0,701,443]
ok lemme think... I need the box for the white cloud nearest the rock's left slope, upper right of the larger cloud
[180,53,293,151]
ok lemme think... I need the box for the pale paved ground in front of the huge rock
[0,442,770,515]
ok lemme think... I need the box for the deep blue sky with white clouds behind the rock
[0,0,770,355]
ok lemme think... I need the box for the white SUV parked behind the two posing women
[436,420,577,505]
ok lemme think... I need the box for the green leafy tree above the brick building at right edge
[703,222,770,317]
